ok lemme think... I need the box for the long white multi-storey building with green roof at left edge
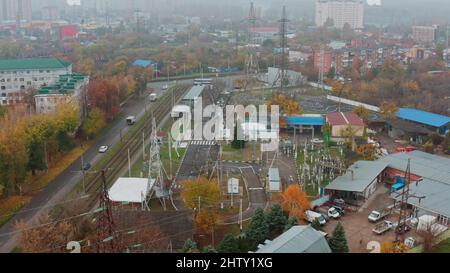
[0,58,72,105]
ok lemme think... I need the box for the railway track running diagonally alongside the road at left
[82,86,189,208]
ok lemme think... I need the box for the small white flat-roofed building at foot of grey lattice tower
[108,177,155,209]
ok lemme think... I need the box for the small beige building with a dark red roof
[325,112,365,139]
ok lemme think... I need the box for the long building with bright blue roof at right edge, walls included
[397,108,450,135]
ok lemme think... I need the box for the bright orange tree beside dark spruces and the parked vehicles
[281,185,311,219]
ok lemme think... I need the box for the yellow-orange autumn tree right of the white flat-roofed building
[181,176,220,209]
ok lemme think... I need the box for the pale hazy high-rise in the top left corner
[1,0,32,22]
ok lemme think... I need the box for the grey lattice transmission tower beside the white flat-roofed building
[146,118,170,210]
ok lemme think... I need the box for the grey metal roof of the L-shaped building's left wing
[326,161,388,192]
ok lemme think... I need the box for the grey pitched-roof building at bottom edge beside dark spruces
[255,225,331,253]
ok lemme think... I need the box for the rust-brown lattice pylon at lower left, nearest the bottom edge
[96,170,121,253]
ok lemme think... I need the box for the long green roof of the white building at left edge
[0,58,71,71]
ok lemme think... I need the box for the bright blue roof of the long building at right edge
[397,108,450,127]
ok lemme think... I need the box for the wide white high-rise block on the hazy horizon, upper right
[316,0,364,29]
